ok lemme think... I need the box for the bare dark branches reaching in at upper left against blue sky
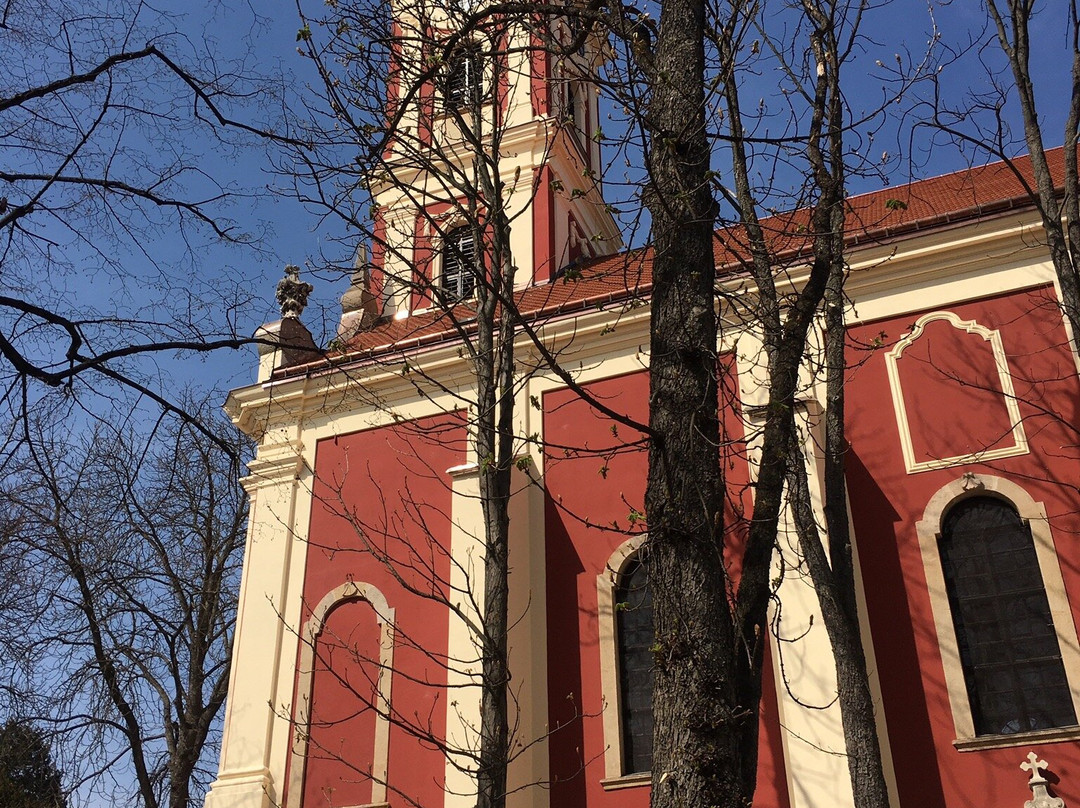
[0,0,298,436]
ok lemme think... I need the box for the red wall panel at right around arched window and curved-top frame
[848,287,1080,808]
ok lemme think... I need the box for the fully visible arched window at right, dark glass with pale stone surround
[916,473,1080,749]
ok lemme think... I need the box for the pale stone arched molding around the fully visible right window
[915,473,1080,750]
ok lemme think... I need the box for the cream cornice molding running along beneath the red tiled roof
[226,212,1053,437]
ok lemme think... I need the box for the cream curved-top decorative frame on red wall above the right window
[885,311,1028,474]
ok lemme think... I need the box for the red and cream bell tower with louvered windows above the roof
[368,0,622,319]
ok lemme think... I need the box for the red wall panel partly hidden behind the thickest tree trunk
[542,372,788,808]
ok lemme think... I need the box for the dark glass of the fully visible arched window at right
[940,497,1077,735]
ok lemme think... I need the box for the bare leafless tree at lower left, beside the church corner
[0,401,247,808]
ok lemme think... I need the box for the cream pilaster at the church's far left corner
[205,428,310,808]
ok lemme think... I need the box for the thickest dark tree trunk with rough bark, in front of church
[646,0,748,808]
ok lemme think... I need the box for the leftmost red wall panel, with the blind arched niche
[286,414,465,808]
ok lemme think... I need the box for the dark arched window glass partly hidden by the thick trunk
[615,558,654,775]
